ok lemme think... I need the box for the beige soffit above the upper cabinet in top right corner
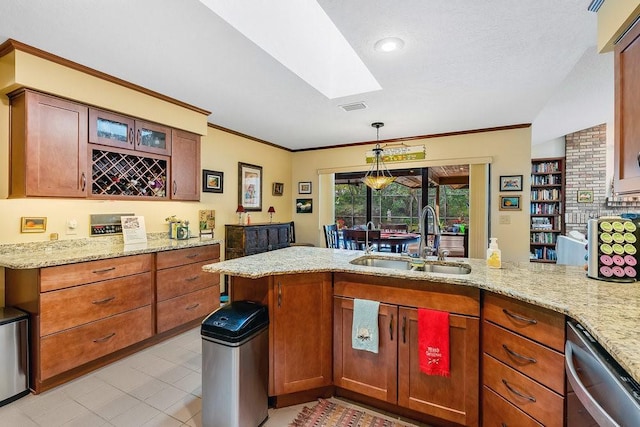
[598,0,640,53]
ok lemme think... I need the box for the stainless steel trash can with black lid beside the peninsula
[200,301,269,427]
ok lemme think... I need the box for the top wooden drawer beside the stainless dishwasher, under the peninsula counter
[483,292,565,353]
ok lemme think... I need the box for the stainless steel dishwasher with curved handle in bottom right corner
[565,321,640,427]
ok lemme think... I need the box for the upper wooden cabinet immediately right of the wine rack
[170,129,200,201]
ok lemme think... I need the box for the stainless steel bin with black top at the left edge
[0,307,29,406]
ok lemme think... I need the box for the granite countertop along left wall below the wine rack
[0,233,221,269]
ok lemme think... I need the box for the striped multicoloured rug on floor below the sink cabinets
[289,399,407,427]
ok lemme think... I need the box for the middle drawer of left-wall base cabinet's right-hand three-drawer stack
[156,261,220,301]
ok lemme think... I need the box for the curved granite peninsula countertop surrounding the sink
[203,246,640,381]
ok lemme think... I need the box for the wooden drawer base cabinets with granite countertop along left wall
[0,233,220,393]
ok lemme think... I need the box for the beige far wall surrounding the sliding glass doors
[292,127,531,261]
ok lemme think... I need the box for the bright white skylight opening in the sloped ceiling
[200,0,382,99]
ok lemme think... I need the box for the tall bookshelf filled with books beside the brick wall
[529,157,565,263]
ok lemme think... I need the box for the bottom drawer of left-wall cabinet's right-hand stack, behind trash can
[157,286,220,333]
